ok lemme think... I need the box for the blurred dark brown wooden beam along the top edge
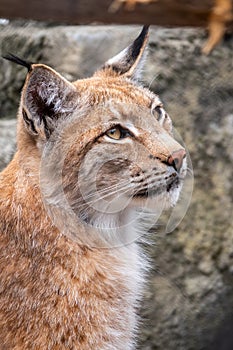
[0,0,224,27]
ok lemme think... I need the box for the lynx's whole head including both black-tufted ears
[5,26,186,246]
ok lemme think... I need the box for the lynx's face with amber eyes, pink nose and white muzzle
[59,100,186,224]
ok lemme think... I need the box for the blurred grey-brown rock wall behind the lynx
[0,22,233,350]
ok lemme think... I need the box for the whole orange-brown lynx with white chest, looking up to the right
[0,26,187,350]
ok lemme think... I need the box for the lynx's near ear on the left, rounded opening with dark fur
[21,64,78,139]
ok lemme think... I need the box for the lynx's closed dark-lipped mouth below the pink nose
[133,176,182,198]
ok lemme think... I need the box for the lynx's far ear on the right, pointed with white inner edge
[96,26,149,79]
